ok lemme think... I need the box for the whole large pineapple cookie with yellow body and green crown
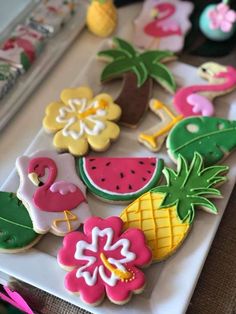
[120,153,228,262]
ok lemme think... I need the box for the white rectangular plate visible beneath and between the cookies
[0,49,236,314]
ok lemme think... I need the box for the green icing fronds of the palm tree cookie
[98,38,176,93]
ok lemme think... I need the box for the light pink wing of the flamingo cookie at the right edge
[187,94,214,117]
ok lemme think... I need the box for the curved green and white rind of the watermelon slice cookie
[76,158,164,202]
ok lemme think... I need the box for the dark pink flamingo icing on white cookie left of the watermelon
[28,157,85,212]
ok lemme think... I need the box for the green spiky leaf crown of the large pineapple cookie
[151,152,229,223]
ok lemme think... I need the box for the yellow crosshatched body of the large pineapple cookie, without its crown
[120,192,190,262]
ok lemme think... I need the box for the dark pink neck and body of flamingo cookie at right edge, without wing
[173,66,236,117]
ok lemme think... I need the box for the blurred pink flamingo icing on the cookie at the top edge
[144,2,182,37]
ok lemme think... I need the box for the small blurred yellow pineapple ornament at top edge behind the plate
[87,0,117,37]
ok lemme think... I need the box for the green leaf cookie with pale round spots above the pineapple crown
[167,117,236,166]
